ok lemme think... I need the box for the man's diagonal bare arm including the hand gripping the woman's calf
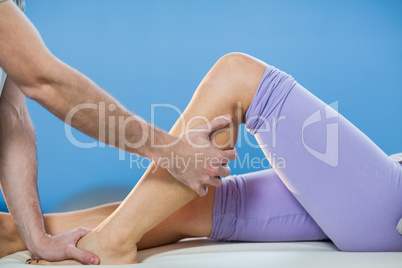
[0,1,236,195]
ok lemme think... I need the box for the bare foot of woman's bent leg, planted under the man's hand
[26,229,137,265]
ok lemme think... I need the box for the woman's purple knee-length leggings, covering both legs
[210,66,402,251]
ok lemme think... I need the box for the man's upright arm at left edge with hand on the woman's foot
[0,78,98,264]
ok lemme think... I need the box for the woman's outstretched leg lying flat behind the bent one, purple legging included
[0,169,327,258]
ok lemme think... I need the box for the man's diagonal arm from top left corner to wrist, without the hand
[0,2,174,158]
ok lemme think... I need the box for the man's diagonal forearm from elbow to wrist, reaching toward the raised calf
[31,60,175,158]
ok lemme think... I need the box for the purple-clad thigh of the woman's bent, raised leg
[246,63,402,251]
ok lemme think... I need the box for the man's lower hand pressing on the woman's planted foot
[30,228,99,265]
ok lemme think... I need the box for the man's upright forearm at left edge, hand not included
[0,81,45,253]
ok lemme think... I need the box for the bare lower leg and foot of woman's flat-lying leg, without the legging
[0,187,215,264]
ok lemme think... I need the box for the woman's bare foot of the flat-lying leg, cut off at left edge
[0,212,26,258]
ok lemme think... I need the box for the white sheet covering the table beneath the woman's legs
[0,239,402,268]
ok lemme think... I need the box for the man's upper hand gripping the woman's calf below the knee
[166,115,237,196]
